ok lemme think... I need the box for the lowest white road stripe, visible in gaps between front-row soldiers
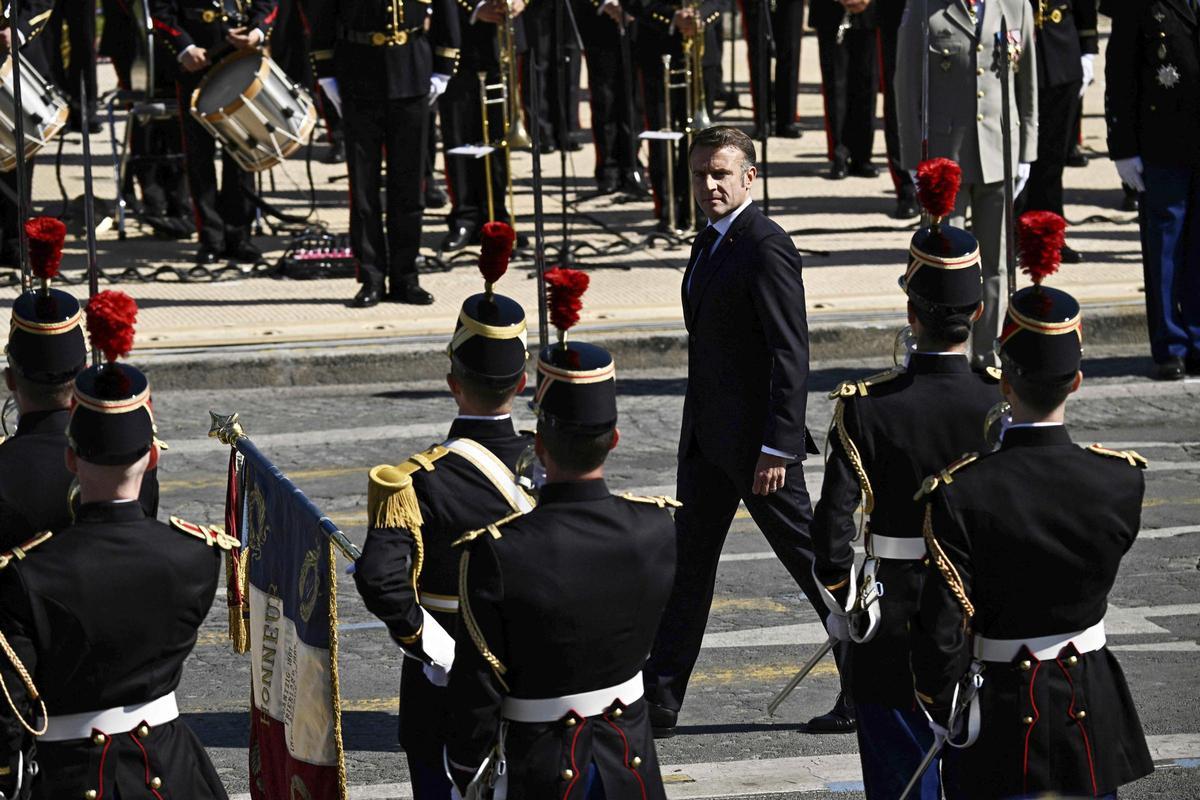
[229,733,1200,800]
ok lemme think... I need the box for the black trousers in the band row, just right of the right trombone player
[738,0,804,128]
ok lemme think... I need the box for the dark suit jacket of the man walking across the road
[679,203,816,470]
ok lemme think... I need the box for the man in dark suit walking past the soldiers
[646,126,853,735]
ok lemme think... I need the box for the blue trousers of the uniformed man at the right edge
[1139,162,1200,363]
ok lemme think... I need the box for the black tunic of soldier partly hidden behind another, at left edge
[0,409,158,551]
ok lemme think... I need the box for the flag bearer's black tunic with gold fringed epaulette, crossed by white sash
[354,419,533,764]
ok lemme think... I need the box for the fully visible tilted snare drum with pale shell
[192,50,317,173]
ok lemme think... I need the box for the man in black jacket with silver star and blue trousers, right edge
[1104,0,1200,380]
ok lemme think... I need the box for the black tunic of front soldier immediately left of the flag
[0,503,227,800]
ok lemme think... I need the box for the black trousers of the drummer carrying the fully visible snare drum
[176,70,254,253]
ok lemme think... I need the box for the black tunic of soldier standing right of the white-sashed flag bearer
[448,480,676,800]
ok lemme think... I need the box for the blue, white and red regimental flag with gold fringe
[227,440,347,800]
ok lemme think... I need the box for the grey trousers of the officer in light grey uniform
[950,181,1008,367]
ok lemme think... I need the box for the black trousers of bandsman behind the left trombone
[438,64,509,230]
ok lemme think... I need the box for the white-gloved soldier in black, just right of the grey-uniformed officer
[1021,0,1099,264]
